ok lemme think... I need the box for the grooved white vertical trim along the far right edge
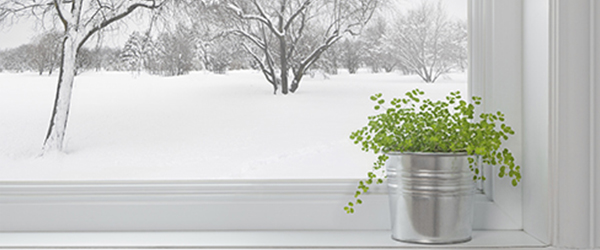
[549,0,600,249]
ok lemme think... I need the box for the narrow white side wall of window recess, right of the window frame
[490,0,524,228]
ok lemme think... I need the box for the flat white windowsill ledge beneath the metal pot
[0,230,547,249]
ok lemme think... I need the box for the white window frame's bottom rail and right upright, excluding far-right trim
[1,1,568,248]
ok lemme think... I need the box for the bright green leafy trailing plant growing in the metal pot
[344,89,521,213]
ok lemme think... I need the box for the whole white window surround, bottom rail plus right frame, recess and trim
[0,0,600,248]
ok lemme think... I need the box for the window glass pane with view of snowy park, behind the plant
[0,0,468,181]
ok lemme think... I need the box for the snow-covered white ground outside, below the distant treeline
[0,70,467,181]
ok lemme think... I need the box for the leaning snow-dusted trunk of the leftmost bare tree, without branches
[43,34,77,153]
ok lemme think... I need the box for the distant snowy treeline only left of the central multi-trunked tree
[0,25,253,76]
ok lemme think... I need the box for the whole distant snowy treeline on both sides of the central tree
[0,0,468,82]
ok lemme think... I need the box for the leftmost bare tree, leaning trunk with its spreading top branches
[0,0,166,152]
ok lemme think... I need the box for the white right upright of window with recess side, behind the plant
[469,0,523,229]
